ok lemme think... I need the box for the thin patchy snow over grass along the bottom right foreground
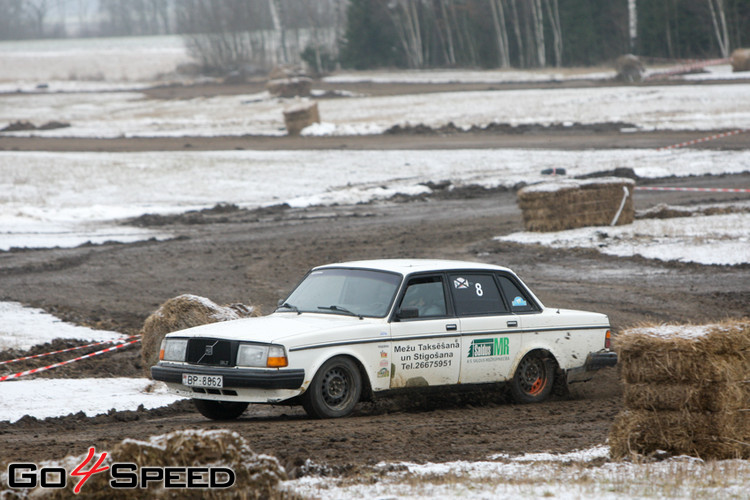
[285,445,750,500]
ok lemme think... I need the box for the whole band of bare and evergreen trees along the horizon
[0,0,750,72]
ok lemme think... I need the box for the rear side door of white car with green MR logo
[448,272,523,384]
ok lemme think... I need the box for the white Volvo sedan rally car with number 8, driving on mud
[151,260,617,419]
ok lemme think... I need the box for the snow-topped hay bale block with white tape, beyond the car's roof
[518,177,635,231]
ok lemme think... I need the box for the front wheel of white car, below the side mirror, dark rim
[302,356,362,418]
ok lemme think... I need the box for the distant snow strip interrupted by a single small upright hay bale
[0,84,750,138]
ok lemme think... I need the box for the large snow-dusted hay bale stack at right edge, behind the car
[609,319,750,459]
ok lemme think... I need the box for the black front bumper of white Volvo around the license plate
[151,363,305,389]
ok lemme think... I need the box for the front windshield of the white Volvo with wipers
[281,268,401,318]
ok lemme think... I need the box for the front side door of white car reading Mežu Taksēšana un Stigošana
[391,274,461,389]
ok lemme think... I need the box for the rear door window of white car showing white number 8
[449,274,508,316]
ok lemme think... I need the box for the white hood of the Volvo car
[162,312,384,343]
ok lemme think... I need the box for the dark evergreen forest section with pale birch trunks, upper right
[342,0,750,68]
